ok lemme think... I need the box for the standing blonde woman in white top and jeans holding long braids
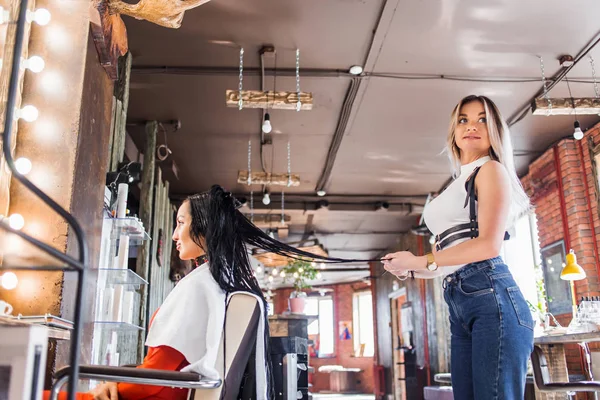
[383,96,534,400]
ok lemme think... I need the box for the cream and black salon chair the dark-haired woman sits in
[50,294,260,400]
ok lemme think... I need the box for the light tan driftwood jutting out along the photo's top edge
[107,0,210,29]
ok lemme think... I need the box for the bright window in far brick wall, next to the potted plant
[304,296,335,357]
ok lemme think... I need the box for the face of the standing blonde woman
[454,101,490,164]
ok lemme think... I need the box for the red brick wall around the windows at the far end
[273,283,375,393]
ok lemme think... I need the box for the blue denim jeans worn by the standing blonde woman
[443,257,534,400]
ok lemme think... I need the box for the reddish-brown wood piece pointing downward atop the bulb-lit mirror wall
[90,0,129,81]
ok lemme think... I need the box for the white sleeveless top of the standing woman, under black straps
[423,156,490,275]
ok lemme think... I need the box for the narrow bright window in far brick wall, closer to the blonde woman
[353,292,375,357]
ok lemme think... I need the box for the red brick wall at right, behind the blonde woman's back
[521,124,600,373]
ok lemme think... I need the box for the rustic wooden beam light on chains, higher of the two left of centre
[225,90,313,111]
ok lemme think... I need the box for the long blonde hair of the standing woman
[447,95,531,227]
